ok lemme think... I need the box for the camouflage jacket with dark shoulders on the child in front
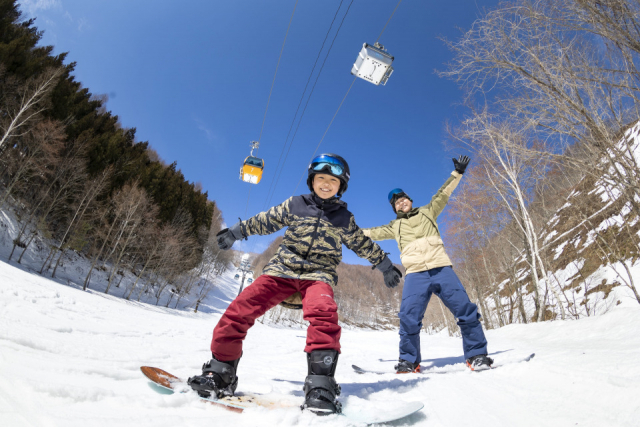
[240,194,385,286]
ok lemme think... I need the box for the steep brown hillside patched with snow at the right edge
[487,123,640,320]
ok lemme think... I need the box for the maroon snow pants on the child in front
[211,274,340,362]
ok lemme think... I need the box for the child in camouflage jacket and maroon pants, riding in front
[188,154,402,415]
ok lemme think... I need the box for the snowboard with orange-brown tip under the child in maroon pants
[140,366,424,424]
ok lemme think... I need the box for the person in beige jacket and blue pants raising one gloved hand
[363,156,493,373]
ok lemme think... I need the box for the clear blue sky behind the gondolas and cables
[21,0,497,263]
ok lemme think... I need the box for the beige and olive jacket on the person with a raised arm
[362,171,462,274]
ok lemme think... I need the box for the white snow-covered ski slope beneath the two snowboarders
[0,262,640,427]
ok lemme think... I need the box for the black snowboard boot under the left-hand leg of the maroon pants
[187,357,240,399]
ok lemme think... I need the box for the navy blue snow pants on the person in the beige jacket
[398,266,487,363]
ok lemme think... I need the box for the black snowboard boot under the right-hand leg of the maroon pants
[300,350,342,415]
